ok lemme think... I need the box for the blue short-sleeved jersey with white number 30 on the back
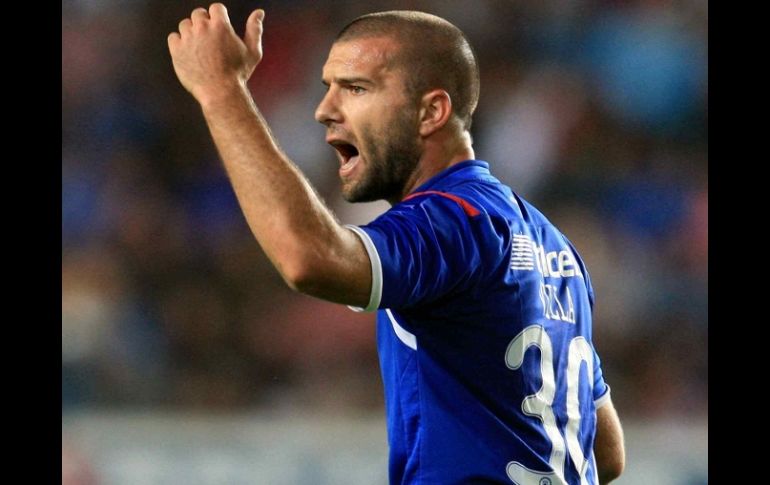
[351,160,609,485]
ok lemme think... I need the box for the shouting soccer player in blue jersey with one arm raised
[168,3,625,485]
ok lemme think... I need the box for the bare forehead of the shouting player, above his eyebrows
[322,37,398,82]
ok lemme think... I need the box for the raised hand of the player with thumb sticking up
[168,3,265,103]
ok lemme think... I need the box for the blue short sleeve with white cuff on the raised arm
[348,195,481,311]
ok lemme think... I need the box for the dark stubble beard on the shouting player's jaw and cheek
[342,114,421,202]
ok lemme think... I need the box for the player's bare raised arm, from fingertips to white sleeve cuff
[168,3,371,307]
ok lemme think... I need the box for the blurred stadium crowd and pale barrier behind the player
[62,0,708,485]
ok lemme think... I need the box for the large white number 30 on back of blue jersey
[505,325,594,485]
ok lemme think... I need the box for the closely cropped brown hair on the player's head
[334,10,480,131]
